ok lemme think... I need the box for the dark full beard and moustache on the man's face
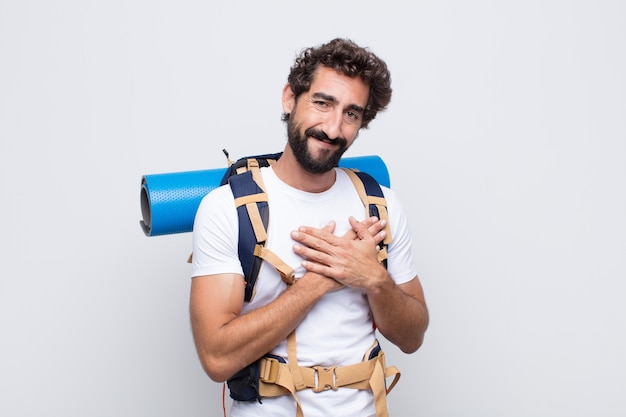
[287,118,348,174]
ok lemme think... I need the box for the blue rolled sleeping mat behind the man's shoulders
[139,155,390,236]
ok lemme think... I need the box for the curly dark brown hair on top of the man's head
[282,38,392,128]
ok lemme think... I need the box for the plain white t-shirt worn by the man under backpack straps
[192,167,417,417]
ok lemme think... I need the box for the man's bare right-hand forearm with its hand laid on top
[292,218,429,353]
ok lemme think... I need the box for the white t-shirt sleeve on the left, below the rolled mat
[191,185,243,277]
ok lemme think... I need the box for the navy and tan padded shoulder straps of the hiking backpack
[220,149,391,302]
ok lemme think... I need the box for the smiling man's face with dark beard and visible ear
[283,67,369,174]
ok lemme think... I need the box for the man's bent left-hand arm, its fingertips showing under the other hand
[190,218,385,382]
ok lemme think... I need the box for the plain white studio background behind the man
[0,0,626,417]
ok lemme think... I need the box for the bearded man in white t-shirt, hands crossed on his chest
[190,39,428,417]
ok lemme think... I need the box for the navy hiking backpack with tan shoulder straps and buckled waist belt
[214,150,400,416]
